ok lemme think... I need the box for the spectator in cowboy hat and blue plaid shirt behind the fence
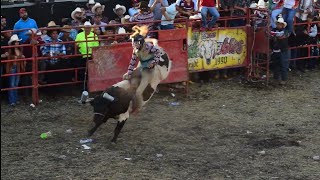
[39,21,66,81]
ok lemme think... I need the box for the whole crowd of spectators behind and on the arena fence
[1,0,320,106]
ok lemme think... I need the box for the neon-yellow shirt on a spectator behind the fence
[75,31,99,58]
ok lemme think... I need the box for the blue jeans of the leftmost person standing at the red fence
[8,65,20,104]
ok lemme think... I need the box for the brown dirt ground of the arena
[1,70,320,180]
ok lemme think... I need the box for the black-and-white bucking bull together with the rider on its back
[88,26,172,142]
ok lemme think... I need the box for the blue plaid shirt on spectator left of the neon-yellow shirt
[42,37,66,64]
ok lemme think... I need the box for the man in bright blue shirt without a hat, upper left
[13,8,38,43]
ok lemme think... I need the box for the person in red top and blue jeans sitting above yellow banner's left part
[198,0,220,31]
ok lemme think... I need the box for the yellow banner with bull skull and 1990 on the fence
[188,27,247,71]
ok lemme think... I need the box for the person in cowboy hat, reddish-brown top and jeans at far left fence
[6,34,26,106]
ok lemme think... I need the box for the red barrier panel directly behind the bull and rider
[88,29,189,92]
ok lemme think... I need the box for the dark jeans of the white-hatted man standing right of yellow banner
[271,50,289,81]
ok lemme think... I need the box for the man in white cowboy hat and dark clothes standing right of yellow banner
[270,17,289,85]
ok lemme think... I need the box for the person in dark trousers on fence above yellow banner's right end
[230,0,250,27]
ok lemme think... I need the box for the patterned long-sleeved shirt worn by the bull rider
[128,43,161,76]
